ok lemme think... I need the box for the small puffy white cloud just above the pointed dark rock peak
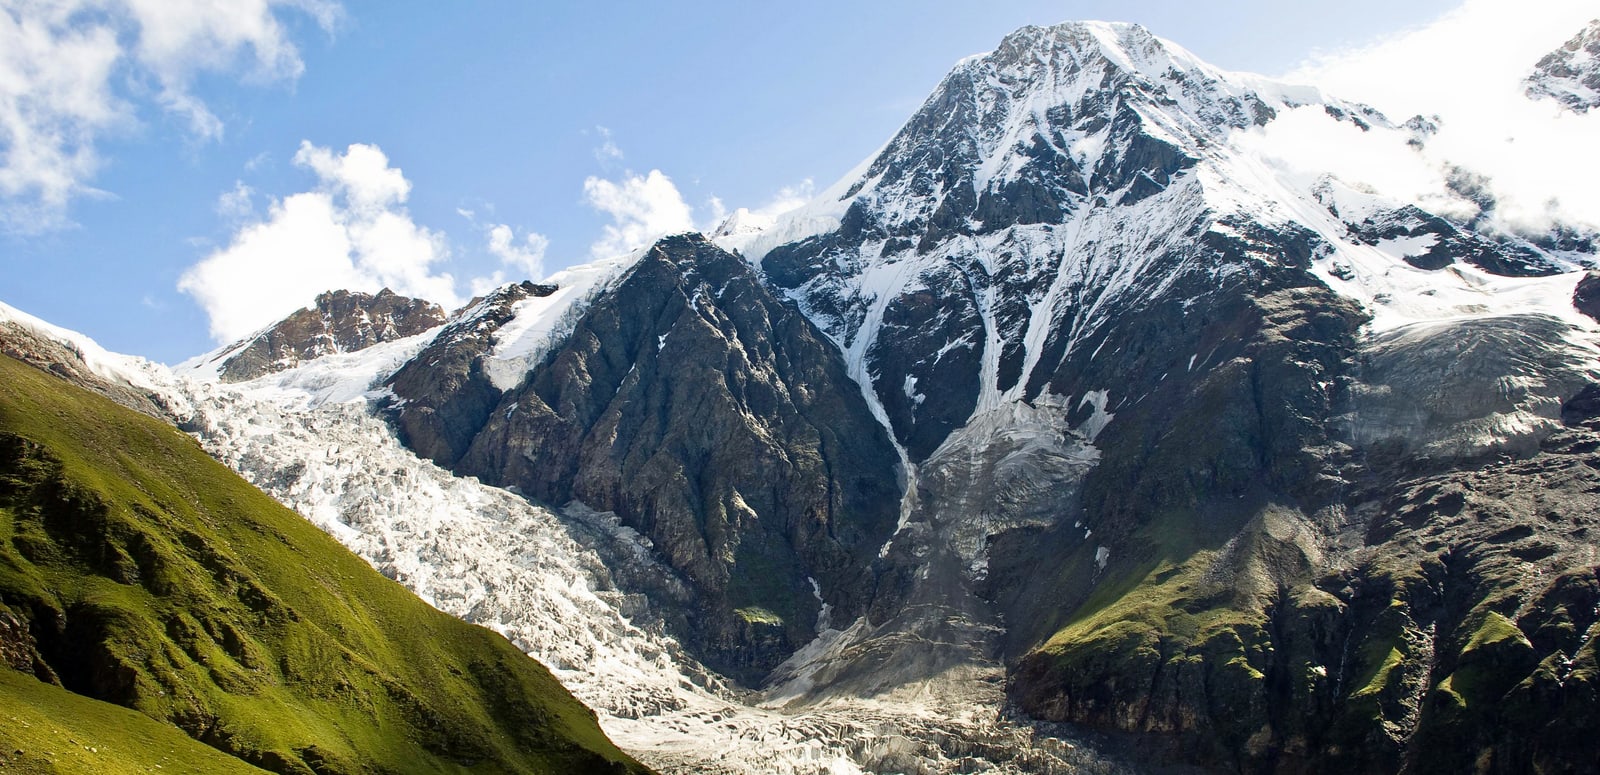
[584,170,694,258]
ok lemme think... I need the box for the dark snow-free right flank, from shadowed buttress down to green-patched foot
[994,310,1600,772]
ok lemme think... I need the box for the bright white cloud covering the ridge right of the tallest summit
[1288,0,1600,232]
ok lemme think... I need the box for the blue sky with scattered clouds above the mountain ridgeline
[0,0,1576,362]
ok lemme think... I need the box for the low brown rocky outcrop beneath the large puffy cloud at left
[218,288,445,383]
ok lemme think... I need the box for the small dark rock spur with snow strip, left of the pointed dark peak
[384,280,555,468]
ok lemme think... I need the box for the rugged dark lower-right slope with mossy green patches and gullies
[1011,428,1600,772]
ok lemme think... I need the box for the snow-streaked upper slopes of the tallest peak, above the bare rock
[744,22,1592,453]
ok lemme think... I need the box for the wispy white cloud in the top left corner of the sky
[0,0,339,232]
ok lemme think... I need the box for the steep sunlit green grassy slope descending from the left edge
[0,357,642,773]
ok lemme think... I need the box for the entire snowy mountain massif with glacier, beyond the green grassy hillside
[12,22,1600,772]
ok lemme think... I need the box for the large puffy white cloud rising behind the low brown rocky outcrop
[178,143,461,343]
